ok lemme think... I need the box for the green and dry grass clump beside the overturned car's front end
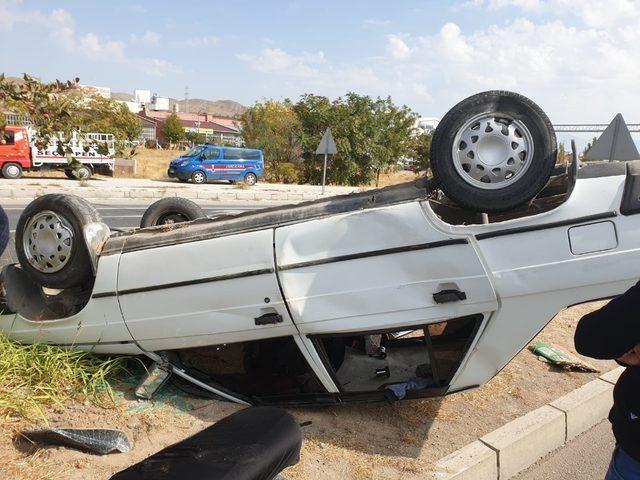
[0,334,125,421]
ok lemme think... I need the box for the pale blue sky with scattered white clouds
[0,0,640,133]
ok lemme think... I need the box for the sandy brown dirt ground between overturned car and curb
[0,302,616,480]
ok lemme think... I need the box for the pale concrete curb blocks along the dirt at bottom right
[431,367,624,480]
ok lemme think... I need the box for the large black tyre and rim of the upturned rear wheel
[431,91,557,212]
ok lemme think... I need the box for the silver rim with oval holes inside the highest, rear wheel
[451,113,533,190]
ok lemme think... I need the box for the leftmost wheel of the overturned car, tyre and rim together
[16,194,101,289]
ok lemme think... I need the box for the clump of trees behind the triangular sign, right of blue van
[240,92,431,185]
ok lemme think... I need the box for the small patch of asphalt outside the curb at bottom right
[515,420,615,480]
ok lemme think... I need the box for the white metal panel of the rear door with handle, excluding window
[275,202,497,334]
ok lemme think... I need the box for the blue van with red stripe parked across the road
[167,145,264,185]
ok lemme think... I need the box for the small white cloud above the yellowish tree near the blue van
[237,48,325,77]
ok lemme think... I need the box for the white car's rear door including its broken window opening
[275,201,498,400]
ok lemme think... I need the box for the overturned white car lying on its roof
[0,92,640,404]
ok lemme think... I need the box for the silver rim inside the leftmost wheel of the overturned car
[22,210,74,273]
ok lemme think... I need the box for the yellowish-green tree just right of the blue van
[241,100,302,183]
